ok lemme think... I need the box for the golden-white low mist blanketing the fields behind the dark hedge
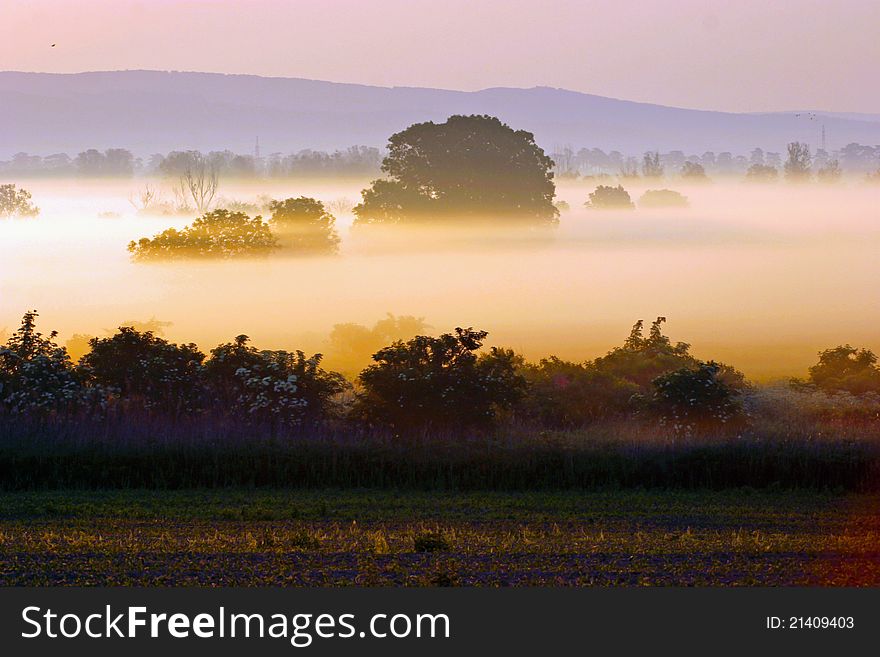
[0,178,880,380]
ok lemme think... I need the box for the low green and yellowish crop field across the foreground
[0,488,880,586]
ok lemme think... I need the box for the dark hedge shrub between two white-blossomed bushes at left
[80,326,205,413]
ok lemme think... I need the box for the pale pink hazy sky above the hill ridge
[0,0,880,112]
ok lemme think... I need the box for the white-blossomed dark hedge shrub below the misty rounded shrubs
[205,335,346,426]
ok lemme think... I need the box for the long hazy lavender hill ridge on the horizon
[0,71,880,158]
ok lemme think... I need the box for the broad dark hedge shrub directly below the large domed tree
[354,328,525,431]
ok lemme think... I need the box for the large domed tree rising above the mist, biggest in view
[354,116,559,223]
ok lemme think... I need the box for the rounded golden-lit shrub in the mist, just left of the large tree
[269,196,340,255]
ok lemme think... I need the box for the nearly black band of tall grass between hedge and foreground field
[0,438,880,492]
